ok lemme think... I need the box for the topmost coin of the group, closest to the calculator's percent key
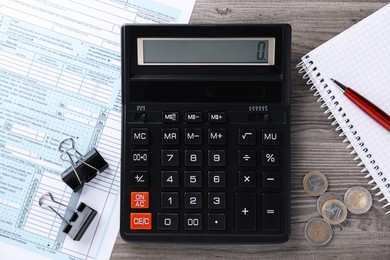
[303,171,328,196]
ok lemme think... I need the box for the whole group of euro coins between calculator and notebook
[303,171,372,246]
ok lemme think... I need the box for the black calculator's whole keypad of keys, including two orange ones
[128,111,286,240]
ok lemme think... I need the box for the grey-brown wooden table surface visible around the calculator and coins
[111,0,390,260]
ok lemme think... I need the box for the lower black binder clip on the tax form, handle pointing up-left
[39,192,97,241]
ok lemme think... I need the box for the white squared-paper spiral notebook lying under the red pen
[297,4,390,213]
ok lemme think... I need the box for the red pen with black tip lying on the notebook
[330,79,390,131]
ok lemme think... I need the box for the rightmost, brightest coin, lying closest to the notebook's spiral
[344,186,372,214]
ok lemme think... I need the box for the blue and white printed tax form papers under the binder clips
[0,0,195,260]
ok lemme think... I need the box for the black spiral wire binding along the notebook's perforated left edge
[296,55,390,214]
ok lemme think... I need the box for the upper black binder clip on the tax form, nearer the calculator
[58,138,108,192]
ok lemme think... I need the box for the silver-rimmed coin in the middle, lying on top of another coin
[321,199,347,225]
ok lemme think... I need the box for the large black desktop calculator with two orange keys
[120,24,291,243]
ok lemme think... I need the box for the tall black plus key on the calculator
[234,192,256,230]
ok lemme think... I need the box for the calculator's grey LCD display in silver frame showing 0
[137,38,275,65]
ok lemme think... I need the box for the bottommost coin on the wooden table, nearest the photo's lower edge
[305,218,333,246]
